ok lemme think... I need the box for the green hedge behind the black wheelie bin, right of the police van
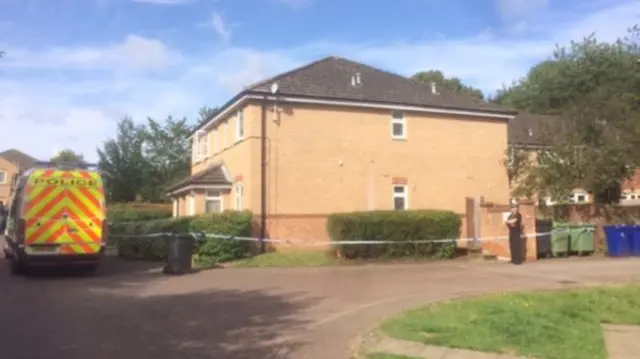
[109,211,255,265]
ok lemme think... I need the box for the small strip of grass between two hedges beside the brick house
[229,251,342,267]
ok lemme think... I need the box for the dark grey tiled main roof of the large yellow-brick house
[194,56,517,132]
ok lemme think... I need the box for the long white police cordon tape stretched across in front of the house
[107,228,592,246]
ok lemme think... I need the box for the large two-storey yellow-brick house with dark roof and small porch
[168,57,516,243]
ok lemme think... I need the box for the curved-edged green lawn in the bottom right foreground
[380,285,640,359]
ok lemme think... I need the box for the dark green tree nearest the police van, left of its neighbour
[98,117,149,202]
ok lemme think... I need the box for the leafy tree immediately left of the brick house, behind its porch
[143,116,191,201]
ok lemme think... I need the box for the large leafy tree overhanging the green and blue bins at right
[510,26,640,202]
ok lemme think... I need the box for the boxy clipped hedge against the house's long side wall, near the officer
[327,210,461,259]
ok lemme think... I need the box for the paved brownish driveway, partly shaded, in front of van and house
[0,242,640,359]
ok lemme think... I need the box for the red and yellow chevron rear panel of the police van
[24,169,105,254]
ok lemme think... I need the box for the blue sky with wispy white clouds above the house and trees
[0,0,640,161]
